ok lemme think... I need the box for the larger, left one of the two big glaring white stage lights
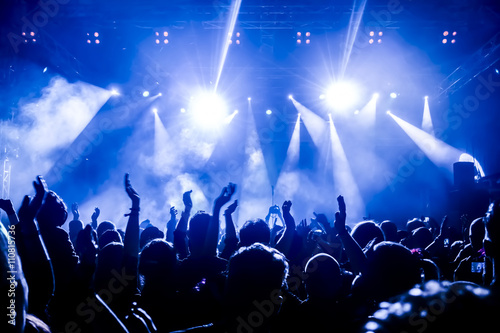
[189,93,228,127]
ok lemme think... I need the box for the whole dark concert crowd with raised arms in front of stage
[0,174,500,333]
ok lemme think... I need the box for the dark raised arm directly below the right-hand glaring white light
[334,195,367,273]
